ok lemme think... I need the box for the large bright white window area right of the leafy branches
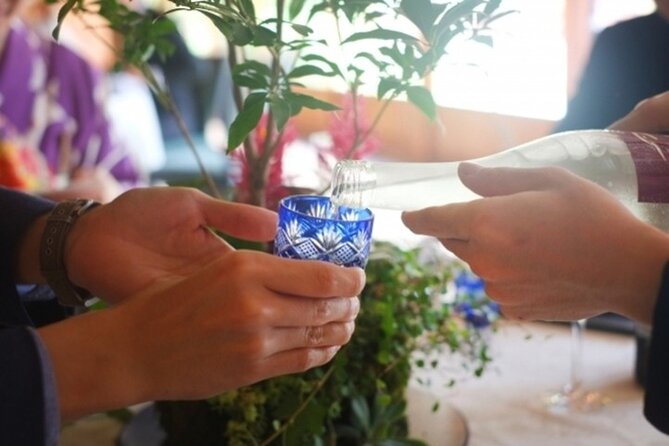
[432,0,567,120]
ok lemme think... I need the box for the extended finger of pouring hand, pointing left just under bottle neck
[402,200,481,241]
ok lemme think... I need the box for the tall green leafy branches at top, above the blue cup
[54,0,504,158]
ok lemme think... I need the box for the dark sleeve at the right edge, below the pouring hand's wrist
[644,263,669,434]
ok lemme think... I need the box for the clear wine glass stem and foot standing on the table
[545,319,607,412]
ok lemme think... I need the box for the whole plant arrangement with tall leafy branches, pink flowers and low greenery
[52,0,504,446]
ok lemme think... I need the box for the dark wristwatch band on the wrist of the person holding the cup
[40,199,100,306]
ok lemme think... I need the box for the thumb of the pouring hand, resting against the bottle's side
[458,163,567,197]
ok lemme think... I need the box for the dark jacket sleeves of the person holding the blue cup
[0,187,60,446]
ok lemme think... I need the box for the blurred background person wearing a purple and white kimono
[0,0,146,202]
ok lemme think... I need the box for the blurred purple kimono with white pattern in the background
[0,22,140,187]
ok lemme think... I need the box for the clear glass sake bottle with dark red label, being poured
[330,130,669,230]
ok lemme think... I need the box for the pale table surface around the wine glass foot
[412,321,669,446]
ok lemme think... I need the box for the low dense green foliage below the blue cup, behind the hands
[155,243,490,446]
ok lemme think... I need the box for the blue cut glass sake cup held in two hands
[274,195,374,268]
